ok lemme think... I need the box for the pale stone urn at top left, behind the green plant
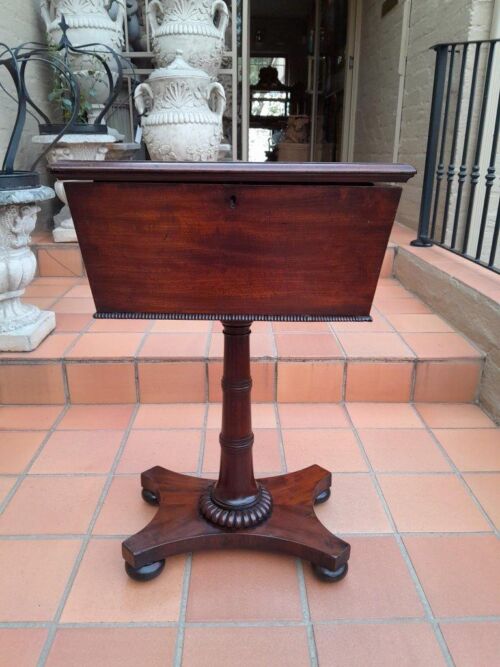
[41,0,126,105]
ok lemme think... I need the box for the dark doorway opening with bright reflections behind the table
[241,0,355,162]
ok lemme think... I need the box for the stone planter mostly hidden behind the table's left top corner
[33,134,116,243]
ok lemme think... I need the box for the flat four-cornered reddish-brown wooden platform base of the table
[122,465,350,572]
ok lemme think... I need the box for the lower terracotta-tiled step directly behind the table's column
[0,277,483,404]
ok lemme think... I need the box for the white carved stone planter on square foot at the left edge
[0,186,56,352]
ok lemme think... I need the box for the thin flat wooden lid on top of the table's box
[50,160,416,185]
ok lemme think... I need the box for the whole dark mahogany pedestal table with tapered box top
[53,162,414,581]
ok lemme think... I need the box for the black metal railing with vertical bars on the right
[412,40,500,273]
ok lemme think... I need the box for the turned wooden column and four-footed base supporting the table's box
[122,321,350,581]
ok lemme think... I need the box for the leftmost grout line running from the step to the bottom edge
[37,404,139,667]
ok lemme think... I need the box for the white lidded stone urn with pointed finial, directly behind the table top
[134,51,226,162]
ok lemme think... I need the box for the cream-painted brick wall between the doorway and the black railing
[354,0,493,228]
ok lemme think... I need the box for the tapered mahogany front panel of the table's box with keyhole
[65,182,401,319]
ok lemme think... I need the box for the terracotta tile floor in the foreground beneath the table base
[0,400,500,667]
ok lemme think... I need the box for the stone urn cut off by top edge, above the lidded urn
[148,0,229,78]
